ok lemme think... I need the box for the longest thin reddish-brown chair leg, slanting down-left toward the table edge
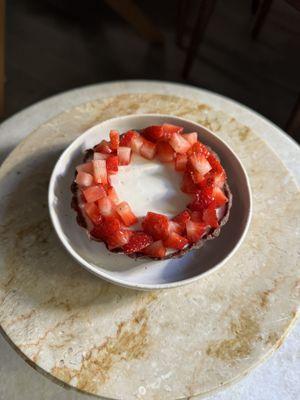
[182,0,216,78]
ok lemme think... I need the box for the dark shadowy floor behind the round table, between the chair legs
[6,0,300,142]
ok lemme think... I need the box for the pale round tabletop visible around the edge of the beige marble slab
[0,81,300,399]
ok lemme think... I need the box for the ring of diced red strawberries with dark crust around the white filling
[72,124,232,260]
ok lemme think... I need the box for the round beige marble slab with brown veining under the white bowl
[0,94,300,400]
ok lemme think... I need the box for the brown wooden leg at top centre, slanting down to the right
[105,0,163,43]
